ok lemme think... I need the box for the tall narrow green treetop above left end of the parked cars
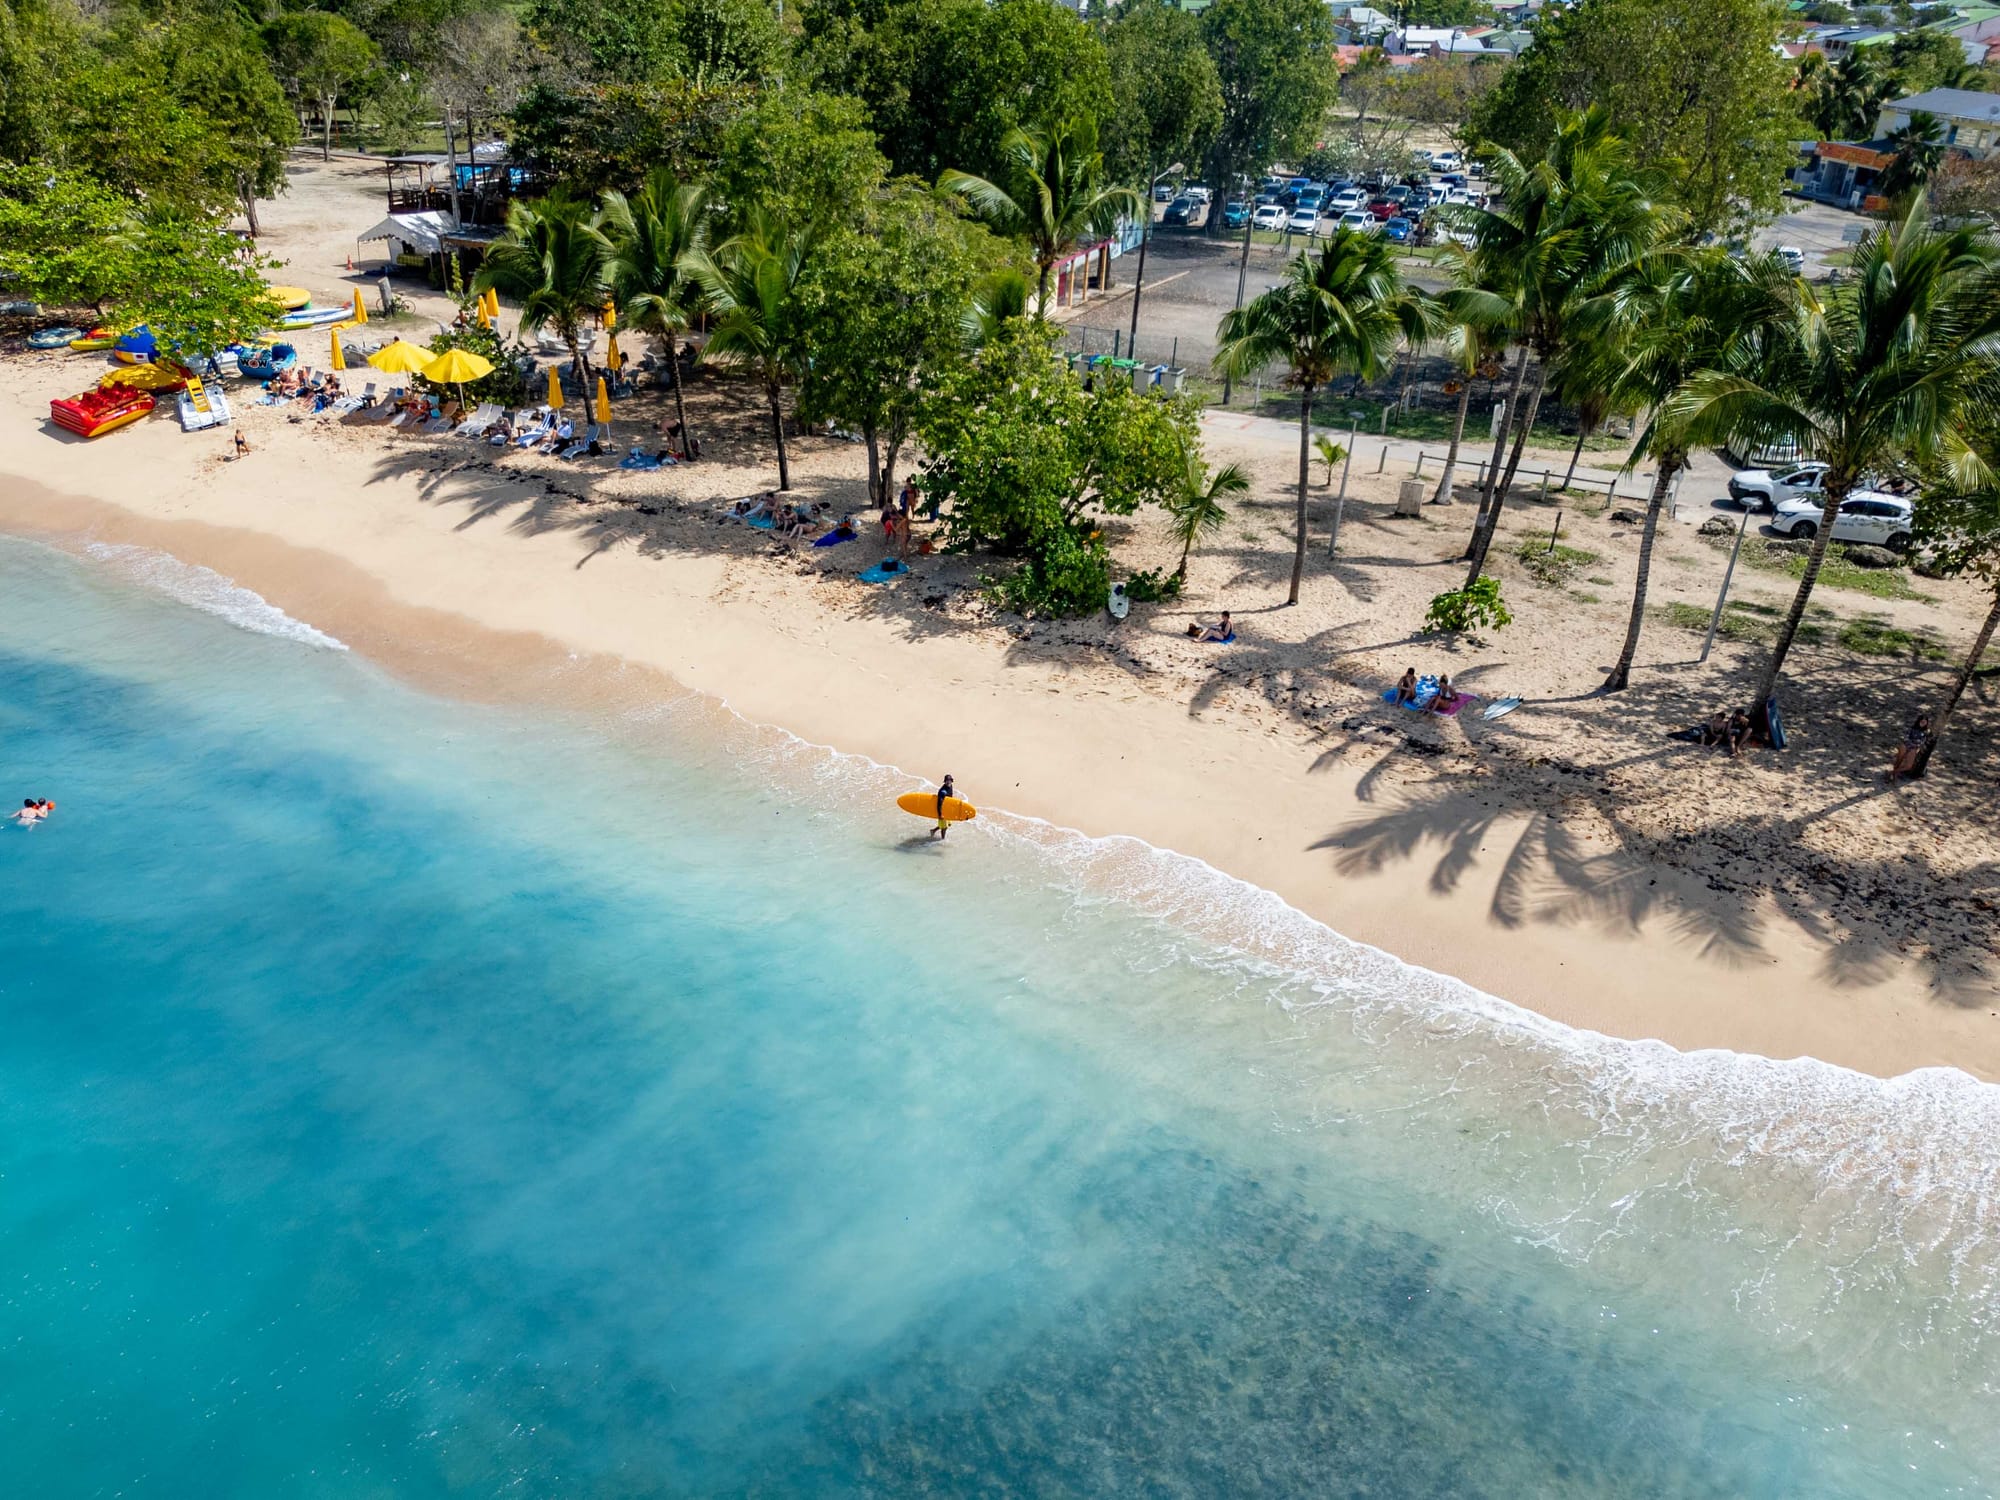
[1202,0,1340,209]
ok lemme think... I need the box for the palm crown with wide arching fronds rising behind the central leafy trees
[938,120,1142,316]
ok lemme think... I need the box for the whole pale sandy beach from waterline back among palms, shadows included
[15,159,2000,1078]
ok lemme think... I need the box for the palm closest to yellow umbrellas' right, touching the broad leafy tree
[686,212,812,490]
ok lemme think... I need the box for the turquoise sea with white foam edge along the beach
[0,542,2000,1500]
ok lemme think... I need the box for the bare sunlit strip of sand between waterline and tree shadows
[0,392,2000,1080]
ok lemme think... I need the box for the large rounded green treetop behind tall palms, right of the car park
[1472,0,1806,234]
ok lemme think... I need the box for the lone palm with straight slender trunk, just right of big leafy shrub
[1216,230,1432,604]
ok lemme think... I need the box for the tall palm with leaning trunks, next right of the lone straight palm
[1460,106,1680,588]
